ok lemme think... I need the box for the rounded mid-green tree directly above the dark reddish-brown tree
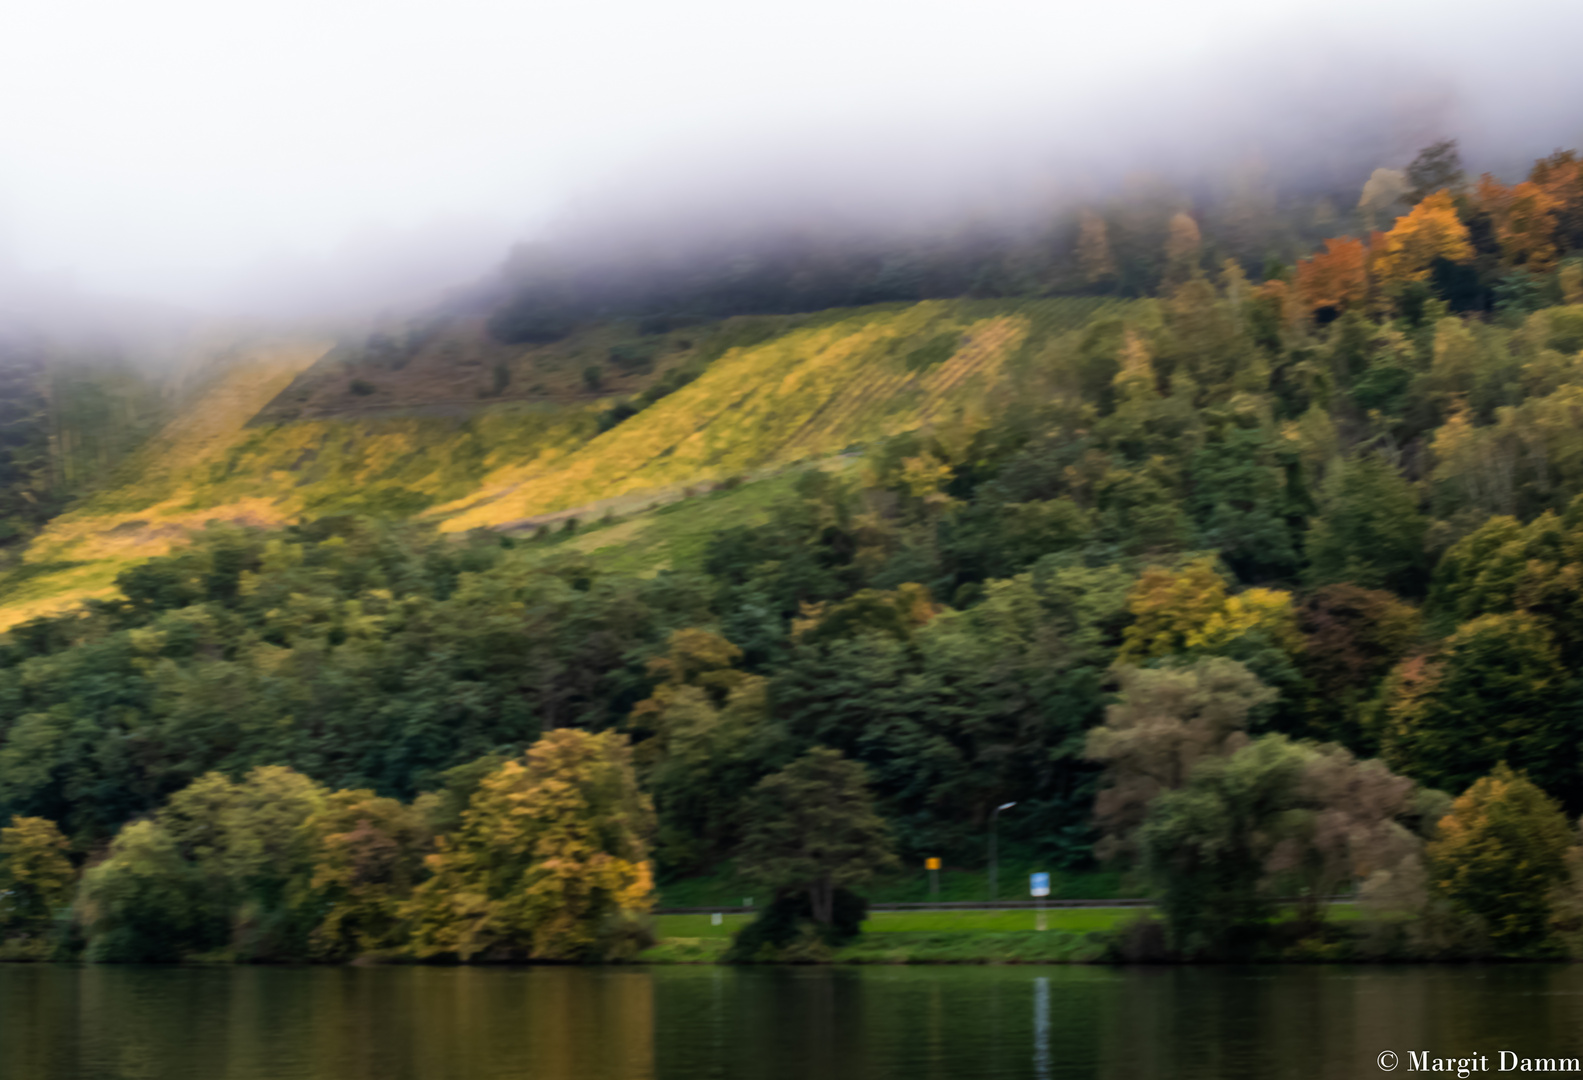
[1308,454,1428,595]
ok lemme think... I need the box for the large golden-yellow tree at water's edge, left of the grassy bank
[405,728,654,960]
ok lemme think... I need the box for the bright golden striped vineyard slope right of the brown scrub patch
[435,301,1092,529]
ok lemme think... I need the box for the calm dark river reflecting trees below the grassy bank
[0,964,1583,1080]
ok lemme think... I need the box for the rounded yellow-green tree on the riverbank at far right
[1426,763,1572,950]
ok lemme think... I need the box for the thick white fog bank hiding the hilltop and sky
[0,0,1583,317]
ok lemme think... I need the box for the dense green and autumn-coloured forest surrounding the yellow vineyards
[0,143,1583,960]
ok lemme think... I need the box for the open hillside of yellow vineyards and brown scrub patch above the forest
[0,299,1121,627]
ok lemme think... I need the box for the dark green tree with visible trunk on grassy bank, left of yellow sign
[738,746,896,925]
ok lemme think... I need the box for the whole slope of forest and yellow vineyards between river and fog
[9,146,1583,958]
